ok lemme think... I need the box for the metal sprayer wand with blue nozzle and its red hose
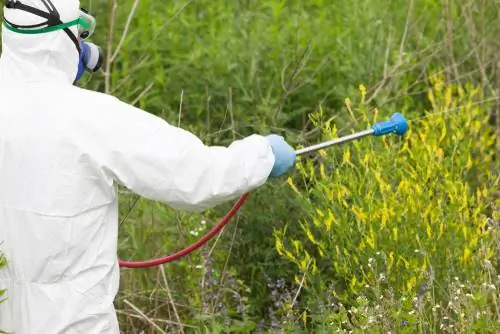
[120,113,408,268]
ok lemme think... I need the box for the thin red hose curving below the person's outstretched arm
[119,194,248,268]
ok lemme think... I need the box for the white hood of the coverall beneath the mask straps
[0,0,80,84]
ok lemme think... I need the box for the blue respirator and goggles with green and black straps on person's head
[3,0,104,82]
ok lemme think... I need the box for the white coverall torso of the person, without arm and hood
[0,81,123,333]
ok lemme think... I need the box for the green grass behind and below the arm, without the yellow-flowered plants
[91,0,498,332]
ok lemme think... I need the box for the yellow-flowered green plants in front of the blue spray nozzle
[275,76,500,330]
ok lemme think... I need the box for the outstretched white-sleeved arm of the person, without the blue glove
[83,94,275,211]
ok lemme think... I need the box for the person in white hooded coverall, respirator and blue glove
[0,0,295,334]
